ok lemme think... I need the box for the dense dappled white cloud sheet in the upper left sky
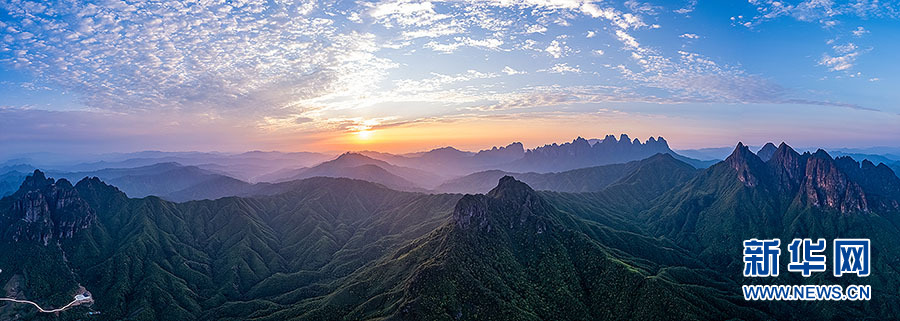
[0,0,393,112]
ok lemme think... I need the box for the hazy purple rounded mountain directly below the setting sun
[275,152,443,191]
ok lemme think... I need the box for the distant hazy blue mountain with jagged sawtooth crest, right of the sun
[500,134,711,173]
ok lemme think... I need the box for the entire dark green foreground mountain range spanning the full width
[0,144,900,320]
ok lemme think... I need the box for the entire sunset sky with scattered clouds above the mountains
[0,0,900,153]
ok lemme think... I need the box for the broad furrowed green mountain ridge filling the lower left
[0,172,459,320]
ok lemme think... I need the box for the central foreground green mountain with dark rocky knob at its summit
[243,177,765,320]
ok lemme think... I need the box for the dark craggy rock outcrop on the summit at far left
[0,170,97,245]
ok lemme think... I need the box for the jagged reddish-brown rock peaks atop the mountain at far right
[725,143,900,213]
